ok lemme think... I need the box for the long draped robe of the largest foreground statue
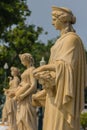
[43,32,86,130]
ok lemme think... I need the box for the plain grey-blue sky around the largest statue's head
[27,0,87,49]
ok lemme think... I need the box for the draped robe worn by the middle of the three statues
[17,66,37,130]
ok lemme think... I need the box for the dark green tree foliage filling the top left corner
[0,0,30,37]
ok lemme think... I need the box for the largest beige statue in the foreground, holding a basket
[33,6,86,130]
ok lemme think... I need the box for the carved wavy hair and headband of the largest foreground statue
[52,6,76,32]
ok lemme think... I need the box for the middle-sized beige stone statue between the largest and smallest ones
[13,53,37,130]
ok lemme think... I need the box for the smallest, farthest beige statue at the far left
[2,67,20,130]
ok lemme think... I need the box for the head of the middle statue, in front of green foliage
[19,53,34,66]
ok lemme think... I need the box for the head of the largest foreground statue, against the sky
[52,6,76,31]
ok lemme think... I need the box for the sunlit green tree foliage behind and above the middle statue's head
[0,24,54,67]
